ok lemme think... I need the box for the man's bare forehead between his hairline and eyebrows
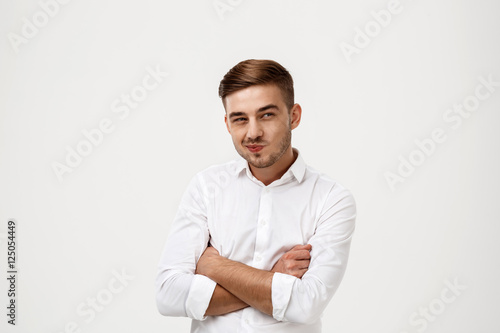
[225,85,285,113]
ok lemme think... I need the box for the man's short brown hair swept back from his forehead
[219,59,294,111]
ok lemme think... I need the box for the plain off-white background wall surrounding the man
[0,0,500,333]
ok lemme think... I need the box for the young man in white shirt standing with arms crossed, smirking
[156,60,356,333]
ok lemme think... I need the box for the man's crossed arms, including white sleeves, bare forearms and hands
[156,182,356,324]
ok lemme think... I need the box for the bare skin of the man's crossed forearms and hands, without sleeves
[196,244,311,316]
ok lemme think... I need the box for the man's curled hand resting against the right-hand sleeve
[271,244,312,279]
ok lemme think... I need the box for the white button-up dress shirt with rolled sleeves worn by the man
[156,148,356,333]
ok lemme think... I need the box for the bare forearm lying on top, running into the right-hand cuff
[206,257,274,316]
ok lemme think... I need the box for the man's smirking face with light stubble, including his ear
[224,85,301,168]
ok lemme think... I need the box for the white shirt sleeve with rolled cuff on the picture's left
[156,177,215,320]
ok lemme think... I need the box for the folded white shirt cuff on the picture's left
[186,274,217,320]
